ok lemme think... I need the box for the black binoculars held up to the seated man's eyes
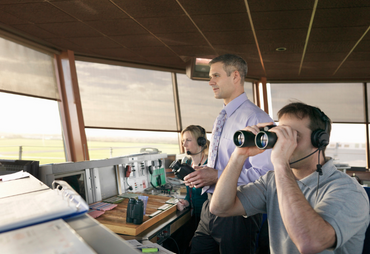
[234,125,277,149]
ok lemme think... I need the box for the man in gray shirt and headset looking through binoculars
[210,103,369,254]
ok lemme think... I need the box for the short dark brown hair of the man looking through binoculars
[277,102,331,157]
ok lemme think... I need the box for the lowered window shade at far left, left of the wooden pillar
[0,38,59,99]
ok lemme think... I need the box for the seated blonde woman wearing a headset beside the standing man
[163,125,210,253]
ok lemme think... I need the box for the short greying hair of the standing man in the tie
[209,54,248,84]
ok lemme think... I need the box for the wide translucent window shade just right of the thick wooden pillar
[76,61,176,131]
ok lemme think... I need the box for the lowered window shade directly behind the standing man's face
[176,74,253,132]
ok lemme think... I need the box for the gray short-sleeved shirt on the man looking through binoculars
[237,160,370,254]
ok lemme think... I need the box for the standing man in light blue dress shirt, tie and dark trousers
[185,54,273,254]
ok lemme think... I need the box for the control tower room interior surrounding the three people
[0,0,370,253]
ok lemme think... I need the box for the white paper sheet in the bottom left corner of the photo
[0,219,96,254]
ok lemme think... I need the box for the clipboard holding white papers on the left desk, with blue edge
[0,180,89,233]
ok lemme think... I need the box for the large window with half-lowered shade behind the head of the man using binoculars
[271,83,366,167]
